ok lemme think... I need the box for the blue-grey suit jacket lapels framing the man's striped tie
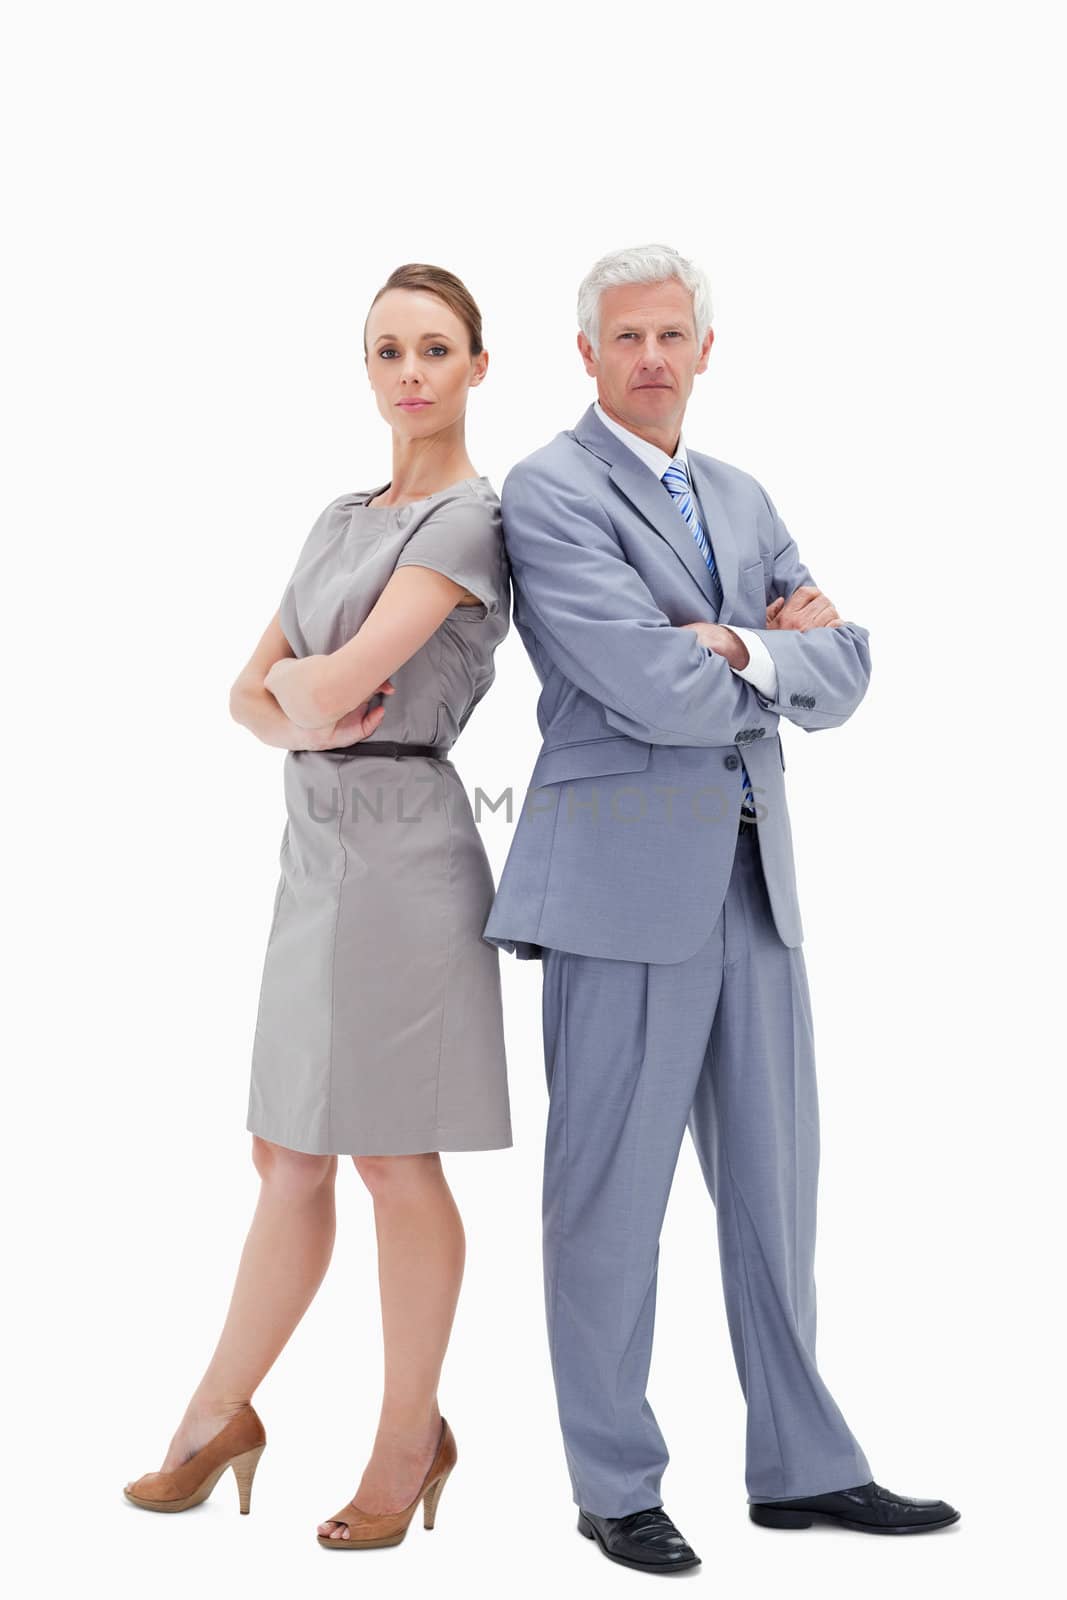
[573,406,737,621]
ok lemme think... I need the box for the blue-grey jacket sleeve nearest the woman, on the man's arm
[501,462,777,746]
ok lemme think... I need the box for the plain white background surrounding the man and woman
[0,0,1064,1600]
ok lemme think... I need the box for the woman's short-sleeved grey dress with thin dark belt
[246,478,512,1155]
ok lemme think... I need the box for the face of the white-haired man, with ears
[577,278,715,454]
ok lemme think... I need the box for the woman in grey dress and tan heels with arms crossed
[125,264,512,1550]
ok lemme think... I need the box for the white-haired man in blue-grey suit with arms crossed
[485,246,960,1571]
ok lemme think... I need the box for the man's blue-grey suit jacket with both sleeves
[483,406,870,962]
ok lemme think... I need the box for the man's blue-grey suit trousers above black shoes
[542,826,872,1517]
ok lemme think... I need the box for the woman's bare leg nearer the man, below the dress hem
[318,1154,466,1538]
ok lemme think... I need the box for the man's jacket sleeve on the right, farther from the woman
[742,480,870,733]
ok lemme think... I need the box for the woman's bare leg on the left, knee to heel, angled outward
[129,1134,338,1472]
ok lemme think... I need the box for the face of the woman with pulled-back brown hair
[366,290,490,438]
